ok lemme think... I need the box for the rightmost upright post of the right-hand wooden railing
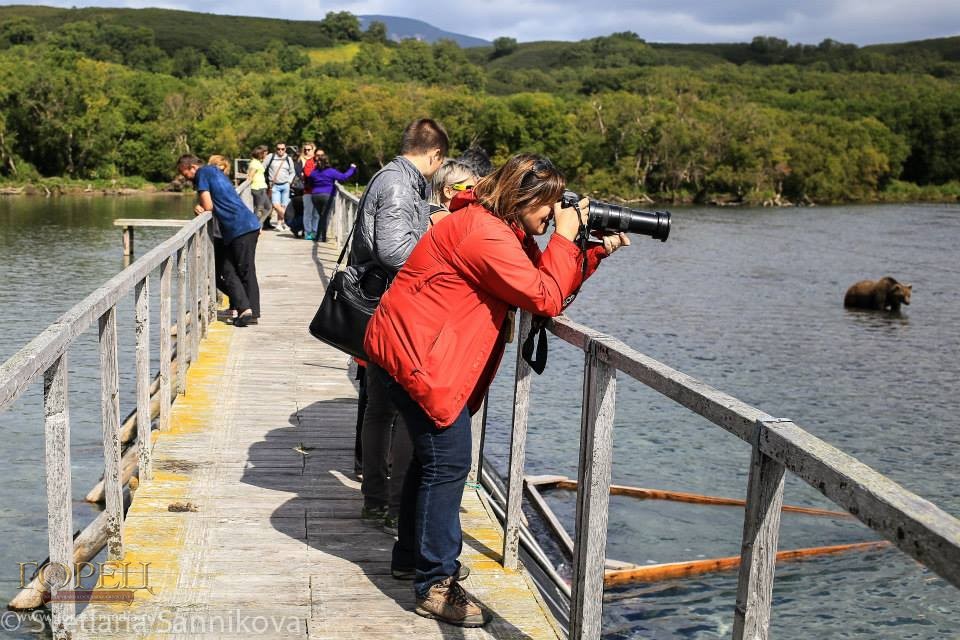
[733,419,785,640]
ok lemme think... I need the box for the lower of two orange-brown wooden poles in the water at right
[603,540,890,587]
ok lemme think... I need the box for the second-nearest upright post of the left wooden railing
[100,306,123,560]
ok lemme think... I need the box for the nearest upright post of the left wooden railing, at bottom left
[43,353,76,640]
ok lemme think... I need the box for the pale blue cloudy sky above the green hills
[11,0,960,45]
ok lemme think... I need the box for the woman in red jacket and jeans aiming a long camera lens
[364,154,629,626]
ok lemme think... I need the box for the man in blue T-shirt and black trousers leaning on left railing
[177,154,260,327]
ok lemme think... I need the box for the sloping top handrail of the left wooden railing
[0,213,212,411]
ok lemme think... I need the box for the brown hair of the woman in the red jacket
[473,153,566,222]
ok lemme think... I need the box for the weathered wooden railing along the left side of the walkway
[0,213,216,639]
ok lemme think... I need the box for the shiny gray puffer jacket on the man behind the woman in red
[350,156,430,276]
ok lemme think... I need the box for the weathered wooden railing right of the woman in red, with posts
[503,312,960,640]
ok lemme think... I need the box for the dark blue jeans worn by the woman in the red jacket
[380,369,472,598]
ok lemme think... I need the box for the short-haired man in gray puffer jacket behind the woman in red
[350,119,449,534]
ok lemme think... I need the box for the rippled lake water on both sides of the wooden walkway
[0,197,960,640]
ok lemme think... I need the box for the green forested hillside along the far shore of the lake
[0,6,960,204]
